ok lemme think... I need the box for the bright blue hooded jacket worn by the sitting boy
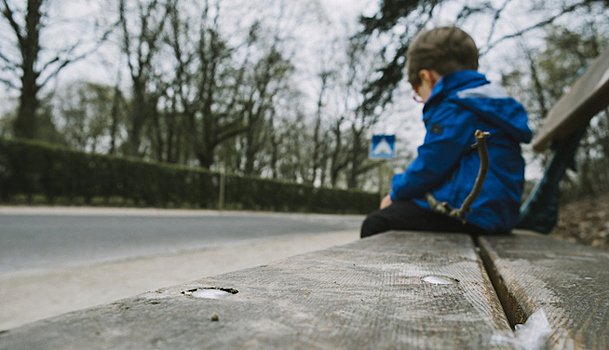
[390,71,532,233]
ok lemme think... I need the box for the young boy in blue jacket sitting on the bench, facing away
[361,27,532,238]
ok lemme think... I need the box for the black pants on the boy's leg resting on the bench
[361,201,485,238]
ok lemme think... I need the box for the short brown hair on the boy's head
[406,27,479,86]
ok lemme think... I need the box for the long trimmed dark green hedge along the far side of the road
[0,139,378,214]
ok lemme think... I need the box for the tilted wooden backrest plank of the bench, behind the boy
[533,48,609,152]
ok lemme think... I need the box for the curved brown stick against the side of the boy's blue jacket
[425,130,490,224]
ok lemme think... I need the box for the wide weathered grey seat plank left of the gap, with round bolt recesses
[0,232,514,349]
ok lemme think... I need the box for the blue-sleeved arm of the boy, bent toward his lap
[390,104,478,201]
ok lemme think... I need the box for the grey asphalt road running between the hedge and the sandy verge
[0,208,362,274]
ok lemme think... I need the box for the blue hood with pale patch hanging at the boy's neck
[426,70,533,143]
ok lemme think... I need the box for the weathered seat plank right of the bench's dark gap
[480,233,609,349]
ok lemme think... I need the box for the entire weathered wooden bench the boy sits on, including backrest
[0,50,609,349]
